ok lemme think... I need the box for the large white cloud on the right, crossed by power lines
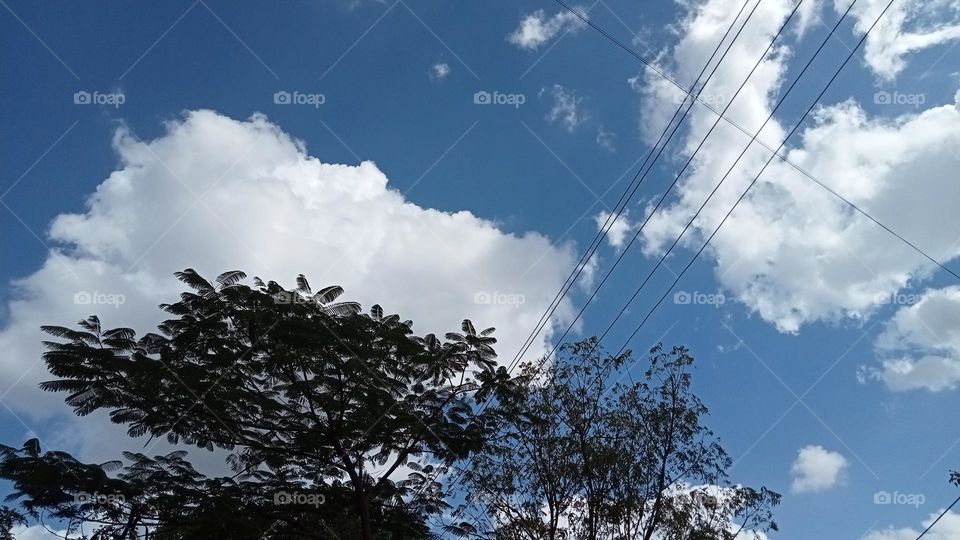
[636,0,960,333]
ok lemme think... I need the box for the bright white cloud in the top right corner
[834,0,960,80]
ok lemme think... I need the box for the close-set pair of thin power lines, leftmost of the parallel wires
[507,0,760,373]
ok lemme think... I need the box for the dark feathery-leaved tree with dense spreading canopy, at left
[0,269,510,540]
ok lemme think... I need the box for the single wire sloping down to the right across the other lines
[554,0,960,280]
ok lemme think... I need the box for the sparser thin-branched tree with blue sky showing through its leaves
[464,338,780,540]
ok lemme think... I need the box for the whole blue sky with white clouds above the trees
[0,0,960,540]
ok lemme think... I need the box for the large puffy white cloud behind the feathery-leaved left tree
[0,111,575,453]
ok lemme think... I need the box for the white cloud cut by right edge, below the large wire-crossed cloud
[871,286,960,392]
